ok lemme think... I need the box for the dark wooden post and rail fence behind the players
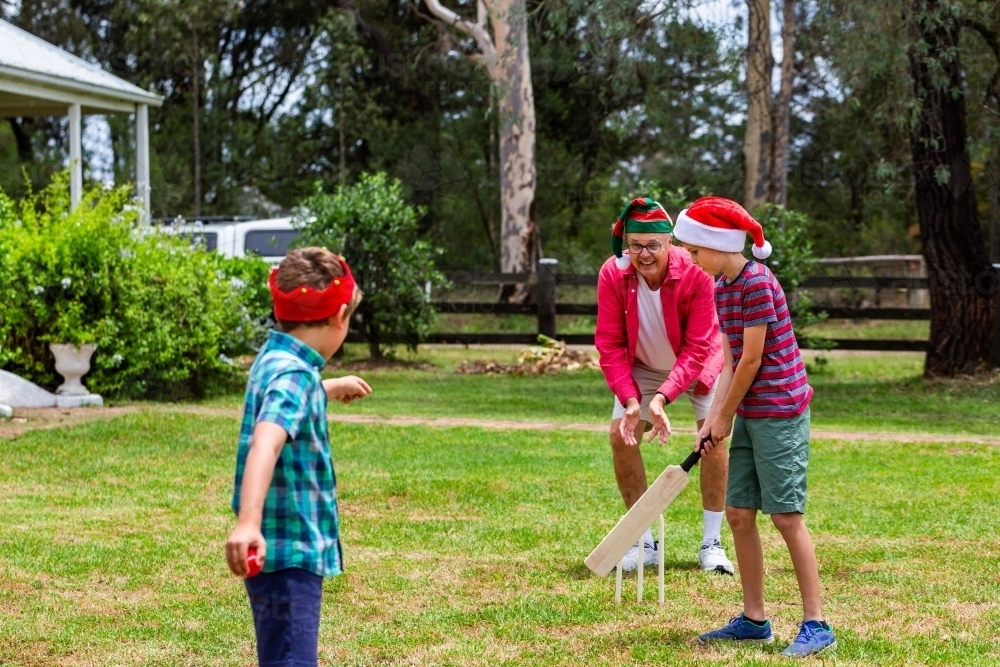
[348,255,1000,366]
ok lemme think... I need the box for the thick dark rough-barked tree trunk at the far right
[908,0,996,376]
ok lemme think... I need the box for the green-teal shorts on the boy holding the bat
[726,408,809,514]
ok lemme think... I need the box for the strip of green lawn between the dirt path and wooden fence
[230,345,1000,436]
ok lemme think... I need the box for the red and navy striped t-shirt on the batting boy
[715,261,813,418]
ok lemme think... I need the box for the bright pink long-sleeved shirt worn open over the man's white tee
[594,245,724,405]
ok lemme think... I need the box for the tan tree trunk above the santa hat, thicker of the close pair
[743,0,774,212]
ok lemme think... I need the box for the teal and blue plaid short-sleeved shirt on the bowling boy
[233,331,343,577]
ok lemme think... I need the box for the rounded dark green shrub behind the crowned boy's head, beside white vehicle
[295,173,446,359]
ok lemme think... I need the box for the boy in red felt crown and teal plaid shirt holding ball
[226,248,371,667]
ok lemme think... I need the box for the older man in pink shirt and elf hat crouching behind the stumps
[594,198,733,574]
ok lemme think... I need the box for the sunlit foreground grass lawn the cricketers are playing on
[0,414,1000,666]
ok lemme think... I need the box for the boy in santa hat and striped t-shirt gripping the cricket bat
[674,197,836,658]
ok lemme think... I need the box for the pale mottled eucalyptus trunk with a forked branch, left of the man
[424,0,542,302]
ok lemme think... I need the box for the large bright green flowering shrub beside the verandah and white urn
[0,173,270,397]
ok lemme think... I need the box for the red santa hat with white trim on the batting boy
[674,197,771,259]
